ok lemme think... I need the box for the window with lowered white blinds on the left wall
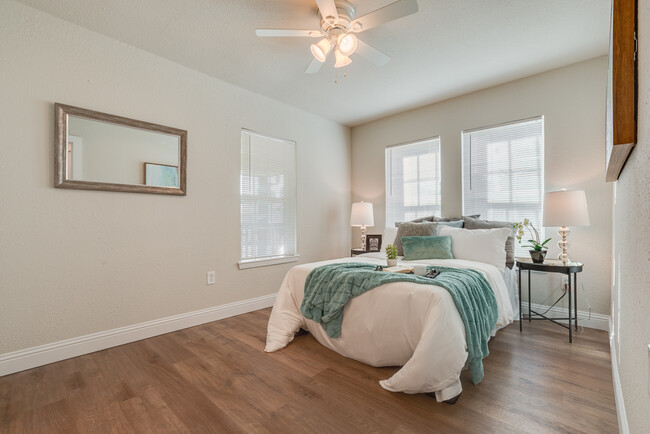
[239,130,297,268]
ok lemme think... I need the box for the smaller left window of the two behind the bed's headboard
[386,137,440,227]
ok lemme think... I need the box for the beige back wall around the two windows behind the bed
[352,57,612,314]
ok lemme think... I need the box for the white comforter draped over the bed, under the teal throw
[265,256,513,401]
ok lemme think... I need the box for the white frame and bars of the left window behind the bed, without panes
[385,136,442,227]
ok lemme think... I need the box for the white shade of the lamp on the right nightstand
[543,190,589,227]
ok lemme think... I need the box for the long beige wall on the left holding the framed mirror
[0,0,351,354]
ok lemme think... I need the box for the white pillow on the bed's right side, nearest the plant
[438,226,512,271]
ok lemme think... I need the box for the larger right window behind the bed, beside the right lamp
[462,117,544,255]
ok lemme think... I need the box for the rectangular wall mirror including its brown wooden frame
[54,103,187,196]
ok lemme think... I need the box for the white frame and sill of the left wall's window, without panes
[238,128,299,269]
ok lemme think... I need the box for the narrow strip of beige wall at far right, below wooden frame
[611,0,650,433]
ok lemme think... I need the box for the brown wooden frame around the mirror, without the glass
[54,103,187,196]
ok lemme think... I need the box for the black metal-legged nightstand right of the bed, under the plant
[517,259,583,343]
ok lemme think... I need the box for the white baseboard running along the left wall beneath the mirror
[0,294,276,377]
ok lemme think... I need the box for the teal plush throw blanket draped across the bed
[300,262,498,384]
